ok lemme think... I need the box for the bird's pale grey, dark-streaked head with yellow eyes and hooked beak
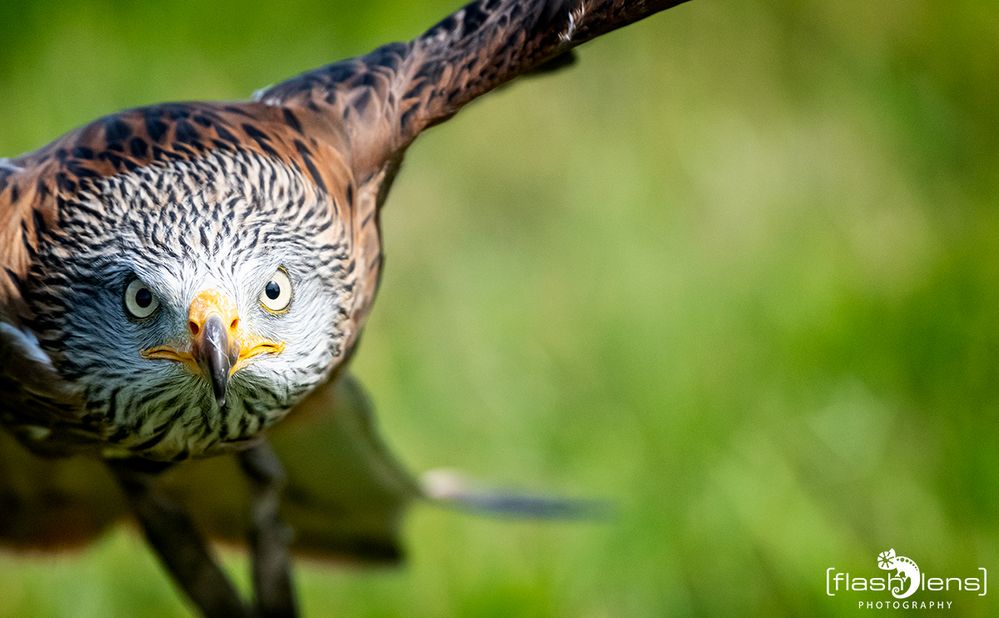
[31,148,353,458]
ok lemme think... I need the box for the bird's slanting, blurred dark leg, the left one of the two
[109,460,249,617]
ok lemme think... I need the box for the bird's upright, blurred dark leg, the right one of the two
[239,442,297,616]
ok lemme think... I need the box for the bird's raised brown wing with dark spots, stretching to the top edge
[257,0,685,182]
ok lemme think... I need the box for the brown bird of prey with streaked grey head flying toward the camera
[0,0,682,615]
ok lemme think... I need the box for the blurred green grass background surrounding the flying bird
[0,0,999,616]
